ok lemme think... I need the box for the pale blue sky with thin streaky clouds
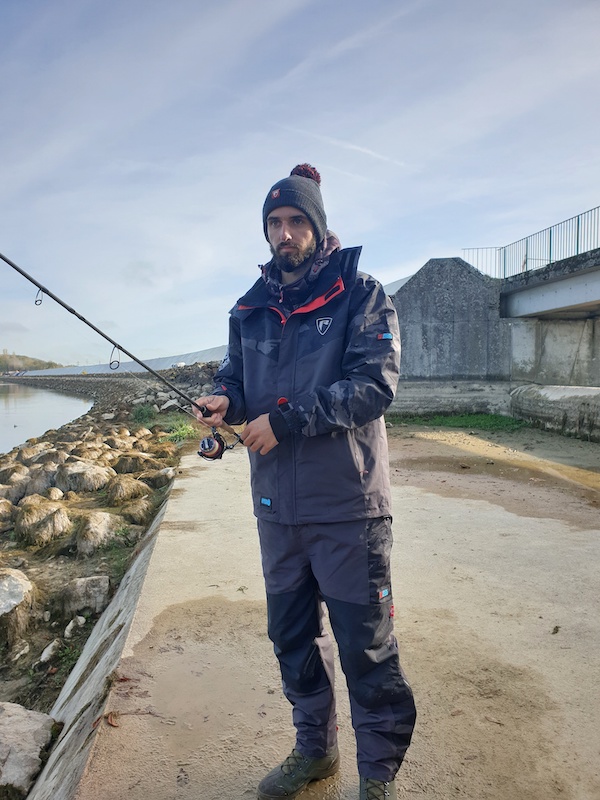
[0,0,600,365]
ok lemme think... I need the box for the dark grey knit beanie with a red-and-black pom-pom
[263,164,327,244]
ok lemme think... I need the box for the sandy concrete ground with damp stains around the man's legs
[78,427,600,800]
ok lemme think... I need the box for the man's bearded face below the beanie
[267,206,317,280]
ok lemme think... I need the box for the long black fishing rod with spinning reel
[0,253,242,460]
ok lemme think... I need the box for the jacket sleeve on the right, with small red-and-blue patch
[288,273,400,436]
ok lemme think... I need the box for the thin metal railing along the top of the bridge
[462,206,600,278]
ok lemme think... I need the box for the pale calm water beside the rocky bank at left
[0,383,92,453]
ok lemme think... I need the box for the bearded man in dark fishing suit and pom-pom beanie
[199,164,416,800]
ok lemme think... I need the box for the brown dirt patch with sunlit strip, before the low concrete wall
[388,426,600,528]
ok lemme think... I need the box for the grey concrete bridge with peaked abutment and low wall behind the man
[393,249,600,441]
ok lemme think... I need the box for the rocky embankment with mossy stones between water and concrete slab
[0,363,217,800]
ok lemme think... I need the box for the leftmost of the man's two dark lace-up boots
[258,747,340,800]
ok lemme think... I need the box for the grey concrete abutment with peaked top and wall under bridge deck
[393,257,600,386]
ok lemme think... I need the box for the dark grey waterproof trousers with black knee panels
[258,517,416,781]
